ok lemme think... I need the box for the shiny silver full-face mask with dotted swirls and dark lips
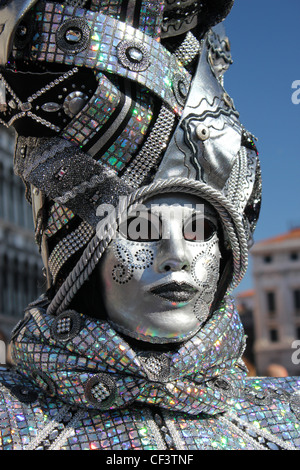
[99,195,220,343]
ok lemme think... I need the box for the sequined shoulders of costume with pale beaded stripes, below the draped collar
[0,368,300,451]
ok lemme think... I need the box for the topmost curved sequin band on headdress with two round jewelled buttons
[15,3,191,114]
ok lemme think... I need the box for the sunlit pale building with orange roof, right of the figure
[251,228,300,375]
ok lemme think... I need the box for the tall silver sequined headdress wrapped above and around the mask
[0,0,261,312]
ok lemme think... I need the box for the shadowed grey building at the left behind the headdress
[0,127,44,338]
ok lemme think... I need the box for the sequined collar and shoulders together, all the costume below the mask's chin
[0,299,300,451]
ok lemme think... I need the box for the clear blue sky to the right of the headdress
[224,0,300,292]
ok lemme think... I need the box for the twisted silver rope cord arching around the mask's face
[48,178,248,315]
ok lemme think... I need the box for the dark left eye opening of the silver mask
[119,212,162,242]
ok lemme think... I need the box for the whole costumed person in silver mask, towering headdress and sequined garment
[0,0,300,451]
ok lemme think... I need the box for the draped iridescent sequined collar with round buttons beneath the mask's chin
[12,299,246,415]
